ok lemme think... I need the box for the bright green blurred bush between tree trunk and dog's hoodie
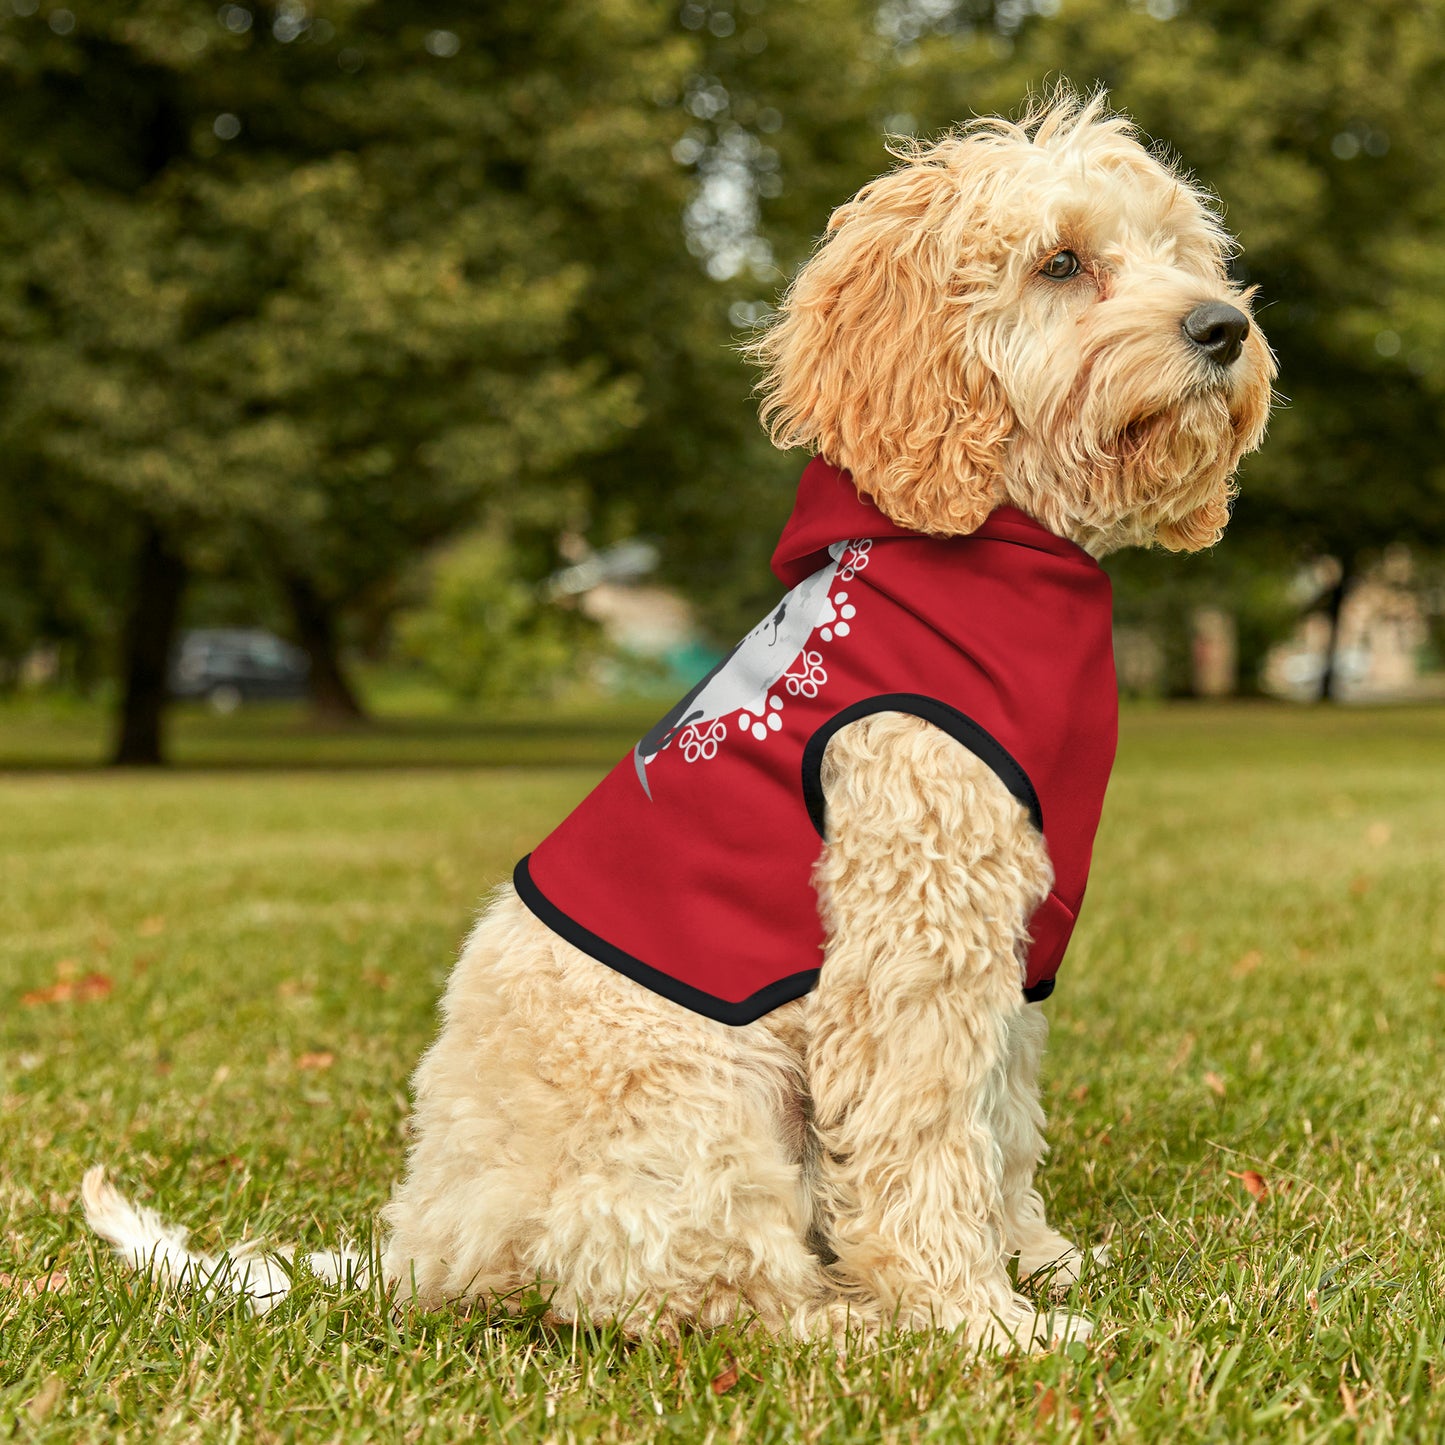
[397,532,598,702]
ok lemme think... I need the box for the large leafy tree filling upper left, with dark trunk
[0,0,688,763]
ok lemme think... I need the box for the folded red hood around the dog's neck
[772,457,1098,587]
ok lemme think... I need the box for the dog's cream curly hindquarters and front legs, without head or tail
[383,714,1082,1342]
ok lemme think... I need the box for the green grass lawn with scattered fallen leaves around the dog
[0,696,1445,1442]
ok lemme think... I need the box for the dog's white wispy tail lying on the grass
[81,1165,371,1315]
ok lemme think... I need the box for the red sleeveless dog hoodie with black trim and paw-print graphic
[514,460,1118,1025]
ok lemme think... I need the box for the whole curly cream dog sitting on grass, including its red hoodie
[87,95,1273,1345]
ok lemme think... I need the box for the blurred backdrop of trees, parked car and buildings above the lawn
[0,0,1445,764]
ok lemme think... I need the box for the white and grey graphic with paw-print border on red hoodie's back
[633,538,873,798]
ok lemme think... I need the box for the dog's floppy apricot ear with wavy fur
[749,151,1013,535]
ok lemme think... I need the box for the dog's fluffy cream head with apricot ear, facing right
[753,92,1274,553]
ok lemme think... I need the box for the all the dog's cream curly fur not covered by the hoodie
[91,94,1273,1347]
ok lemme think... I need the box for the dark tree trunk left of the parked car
[111,522,186,767]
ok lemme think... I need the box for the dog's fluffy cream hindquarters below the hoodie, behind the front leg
[384,889,825,1337]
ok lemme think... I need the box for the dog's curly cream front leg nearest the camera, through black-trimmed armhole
[808,714,1088,1345]
